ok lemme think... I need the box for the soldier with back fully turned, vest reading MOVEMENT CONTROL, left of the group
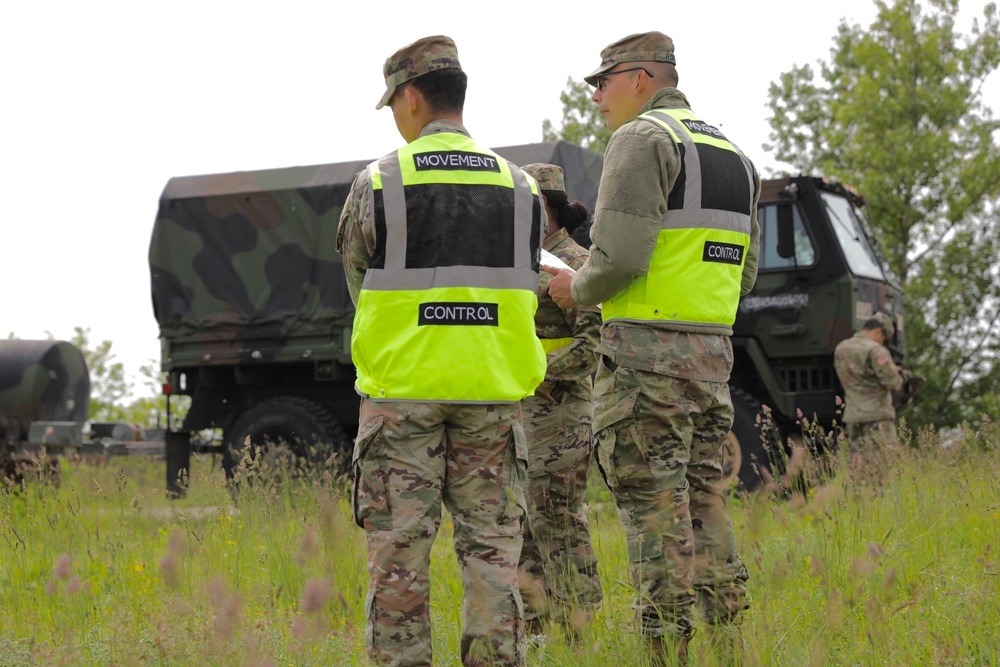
[337,36,545,667]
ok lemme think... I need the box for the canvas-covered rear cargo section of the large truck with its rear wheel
[149,142,601,494]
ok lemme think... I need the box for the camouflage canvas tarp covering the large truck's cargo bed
[149,141,603,340]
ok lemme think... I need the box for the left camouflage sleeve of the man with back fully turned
[337,169,375,306]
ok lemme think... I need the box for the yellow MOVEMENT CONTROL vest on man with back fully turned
[351,132,545,403]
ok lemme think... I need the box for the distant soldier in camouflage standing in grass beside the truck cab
[833,312,903,469]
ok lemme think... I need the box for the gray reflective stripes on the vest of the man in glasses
[644,111,754,235]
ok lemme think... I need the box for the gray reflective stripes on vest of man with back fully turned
[362,153,538,292]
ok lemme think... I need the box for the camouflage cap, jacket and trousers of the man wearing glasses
[571,33,760,646]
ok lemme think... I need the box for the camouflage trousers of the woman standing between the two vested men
[518,394,602,627]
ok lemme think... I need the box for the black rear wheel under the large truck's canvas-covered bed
[222,396,348,479]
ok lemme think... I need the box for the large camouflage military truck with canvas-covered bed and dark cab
[149,141,904,494]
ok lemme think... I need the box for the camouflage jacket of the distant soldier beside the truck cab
[833,331,903,424]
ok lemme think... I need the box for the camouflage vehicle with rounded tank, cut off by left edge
[0,339,163,478]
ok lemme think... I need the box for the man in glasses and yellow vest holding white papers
[549,32,760,663]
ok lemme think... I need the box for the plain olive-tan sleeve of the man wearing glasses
[570,133,680,306]
